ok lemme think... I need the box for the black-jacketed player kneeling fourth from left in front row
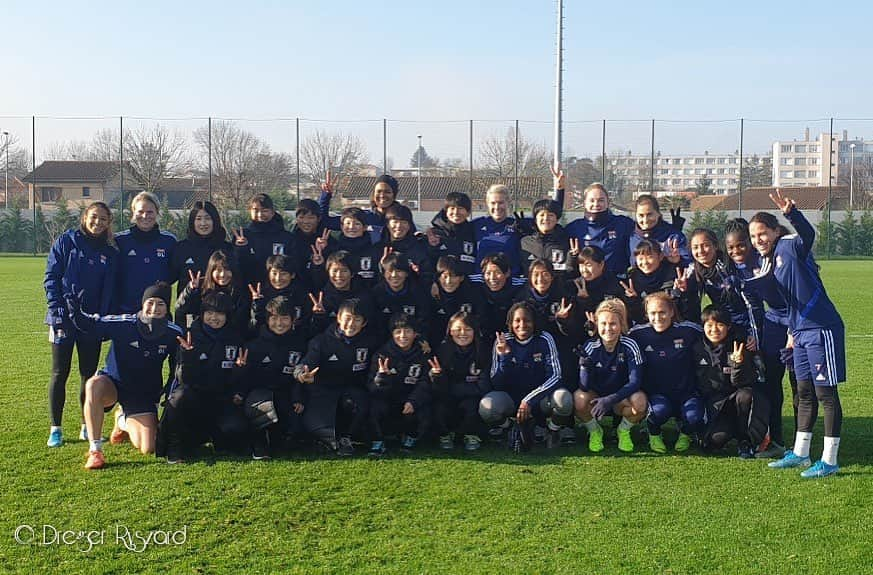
[294,298,380,456]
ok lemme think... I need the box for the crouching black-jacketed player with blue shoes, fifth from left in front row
[367,313,431,457]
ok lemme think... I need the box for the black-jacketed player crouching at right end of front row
[694,305,770,459]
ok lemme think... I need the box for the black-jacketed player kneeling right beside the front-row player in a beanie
[156,291,246,463]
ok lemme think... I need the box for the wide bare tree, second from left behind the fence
[194,120,293,209]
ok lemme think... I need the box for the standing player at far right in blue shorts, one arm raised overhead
[749,191,846,478]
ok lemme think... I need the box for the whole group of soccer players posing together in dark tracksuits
[45,172,845,477]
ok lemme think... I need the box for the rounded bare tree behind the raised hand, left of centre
[300,130,368,185]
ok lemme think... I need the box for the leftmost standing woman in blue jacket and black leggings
[43,202,118,447]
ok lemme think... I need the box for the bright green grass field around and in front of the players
[0,257,873,574]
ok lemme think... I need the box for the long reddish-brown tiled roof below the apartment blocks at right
[691,186,849,212]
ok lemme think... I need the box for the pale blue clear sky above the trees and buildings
[0,0,873,165]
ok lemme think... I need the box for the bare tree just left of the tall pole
[479,128,551,178]
